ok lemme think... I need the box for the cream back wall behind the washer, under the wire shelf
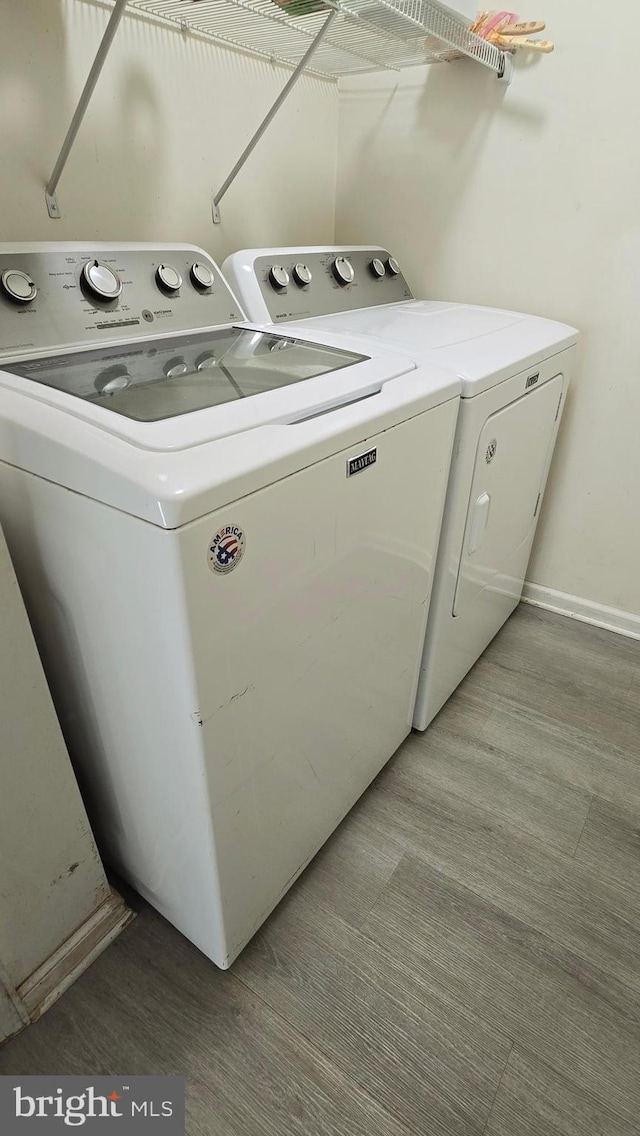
[0,0,338,260]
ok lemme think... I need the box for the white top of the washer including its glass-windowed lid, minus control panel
[0,328,459,528]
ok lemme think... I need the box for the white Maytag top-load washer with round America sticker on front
[0,244,459,967]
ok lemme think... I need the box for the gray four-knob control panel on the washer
[0,243,244,359]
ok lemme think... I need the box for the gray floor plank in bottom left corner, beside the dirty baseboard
[0,910,416,1136]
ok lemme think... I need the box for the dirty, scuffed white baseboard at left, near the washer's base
[18,891,134,1021]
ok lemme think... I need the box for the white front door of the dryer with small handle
[452,375,564,618]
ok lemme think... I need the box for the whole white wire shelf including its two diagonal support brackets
[45,0,512,224]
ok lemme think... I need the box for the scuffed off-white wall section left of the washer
[0,531,110,988]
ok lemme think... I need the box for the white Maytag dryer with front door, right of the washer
[223,247,577,729]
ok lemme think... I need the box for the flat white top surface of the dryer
[285,300,577,399]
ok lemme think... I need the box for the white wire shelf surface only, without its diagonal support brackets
[128,0,505,77]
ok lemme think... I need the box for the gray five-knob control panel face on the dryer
[255,249,414,323]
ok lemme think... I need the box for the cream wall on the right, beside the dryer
[336,0,640,630]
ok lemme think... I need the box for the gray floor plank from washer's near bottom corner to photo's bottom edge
[234,895,510,1136]
